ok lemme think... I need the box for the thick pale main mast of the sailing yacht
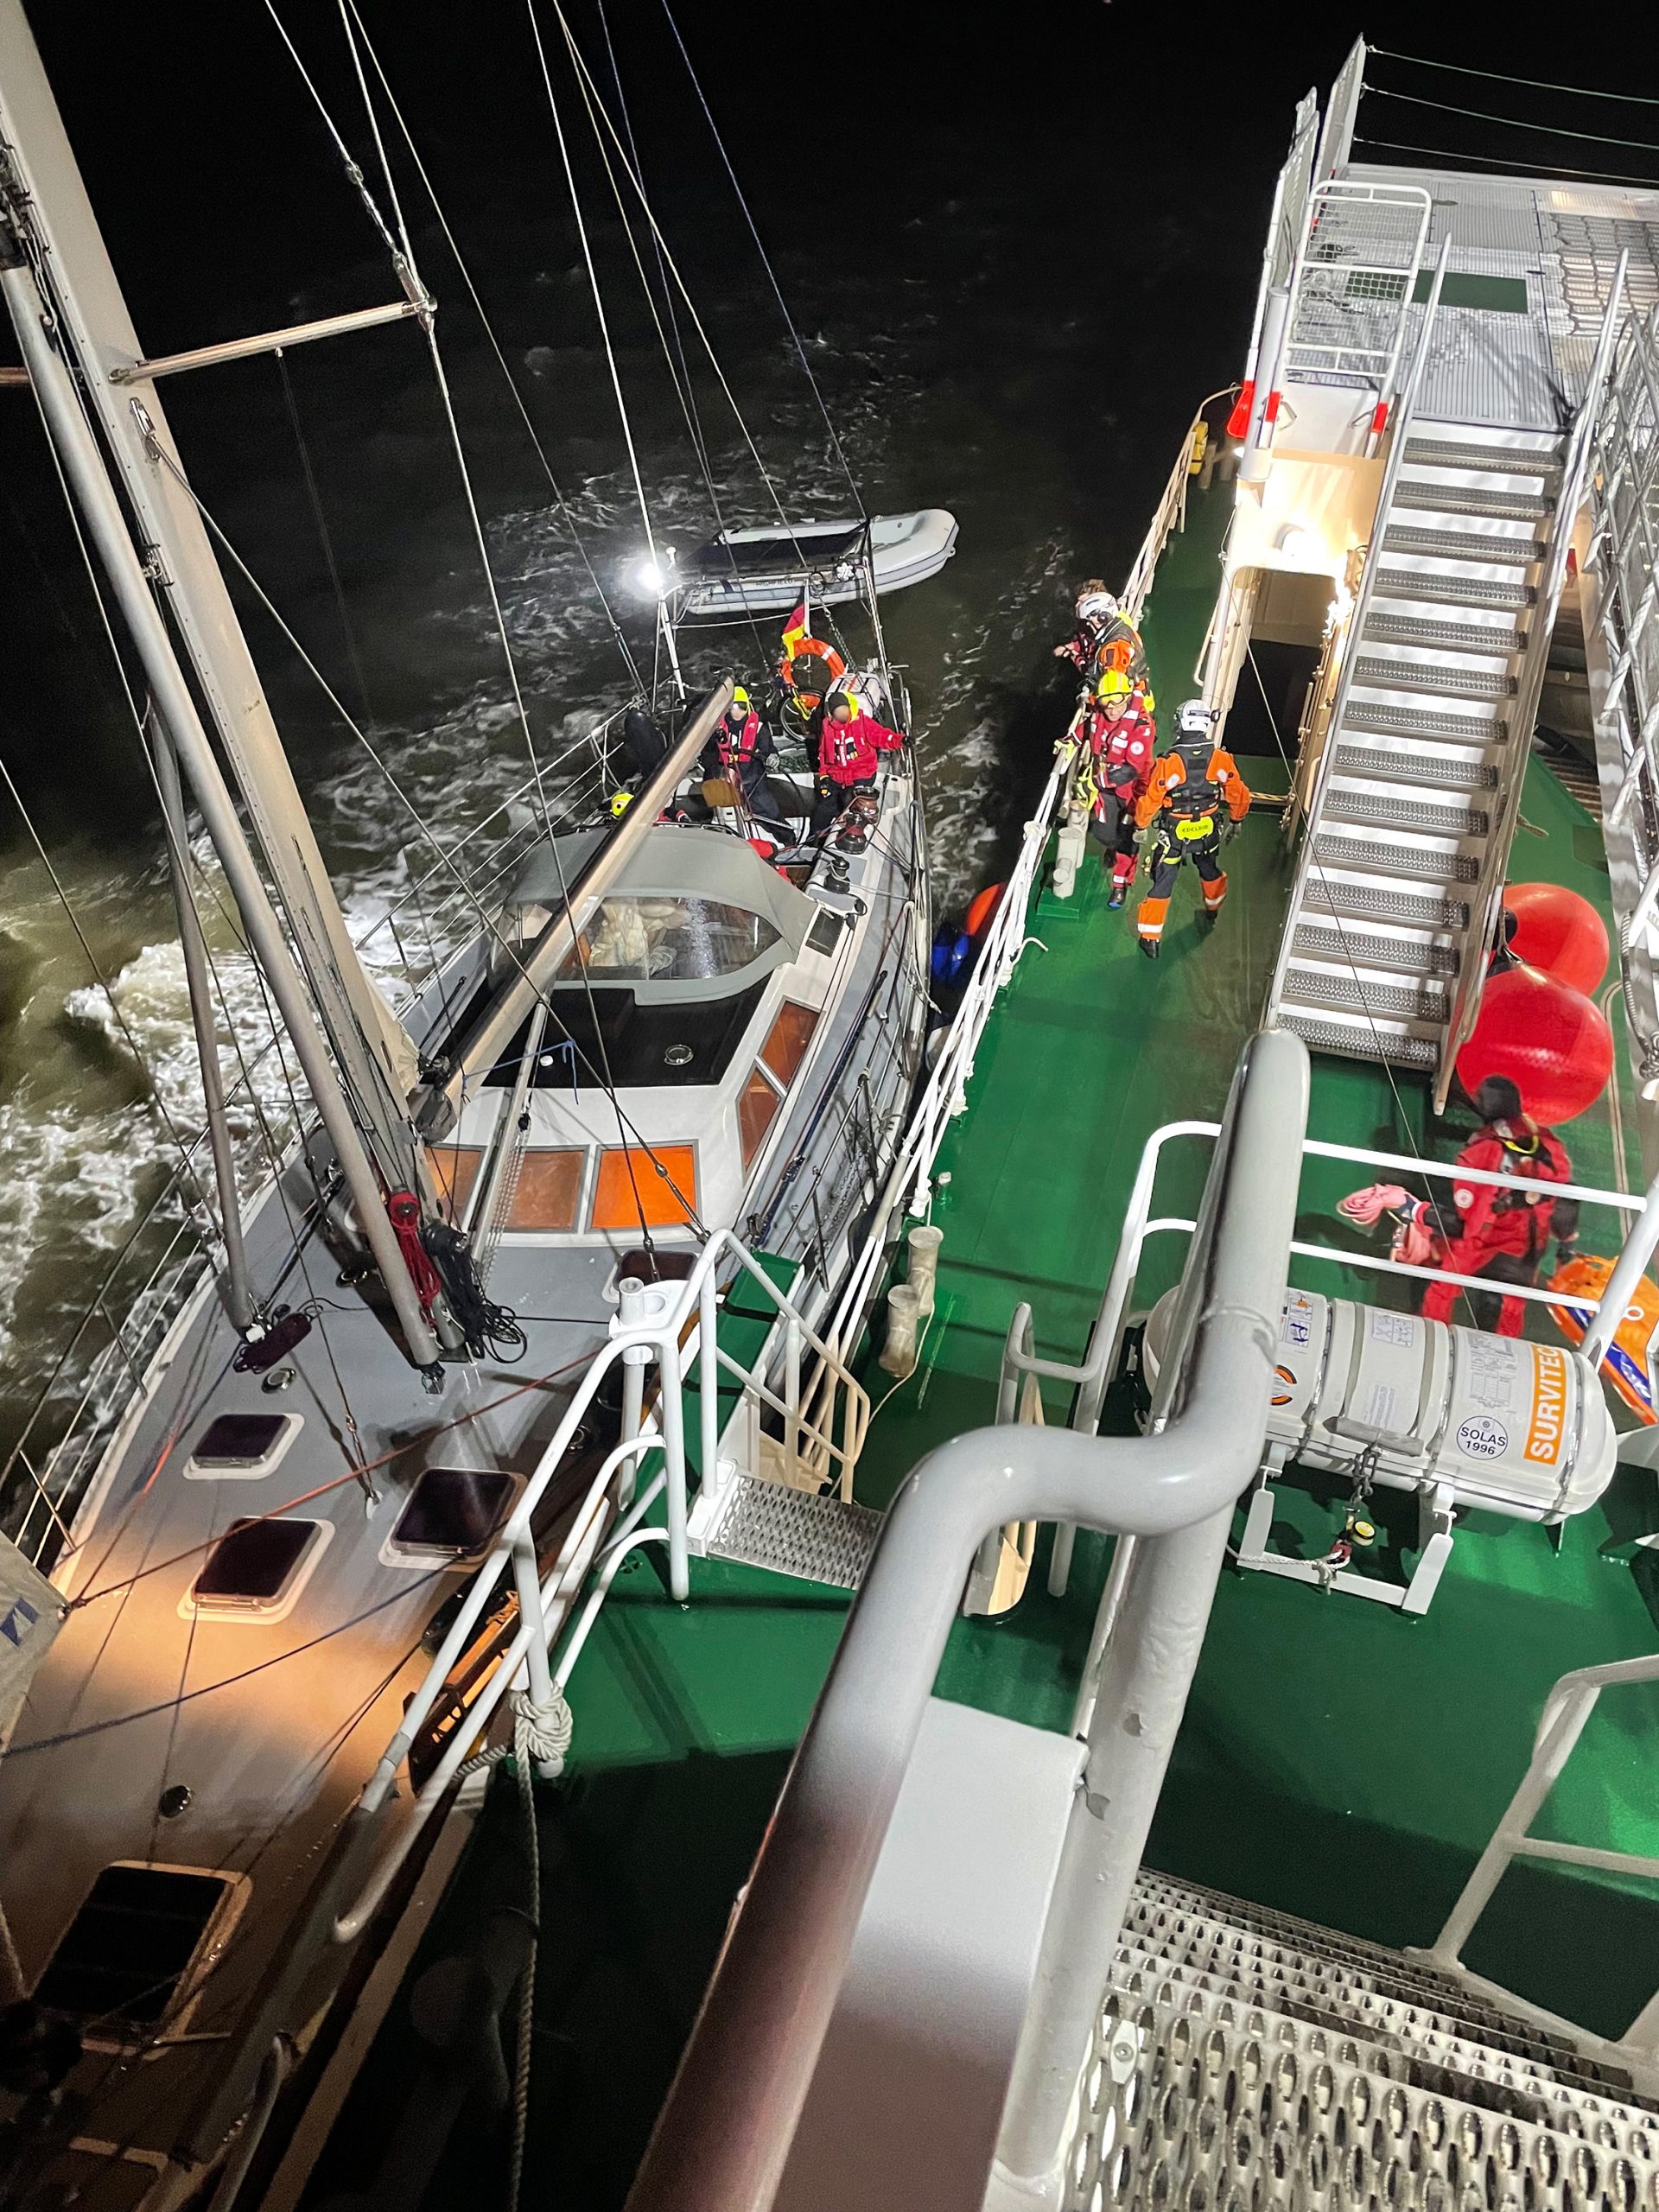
[0,0,420,1188]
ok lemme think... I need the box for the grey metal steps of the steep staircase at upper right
[1276,423,1564,1073]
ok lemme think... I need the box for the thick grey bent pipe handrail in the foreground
[631,1031,1307,2212]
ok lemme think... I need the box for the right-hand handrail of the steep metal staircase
[1433,250,1659,1113]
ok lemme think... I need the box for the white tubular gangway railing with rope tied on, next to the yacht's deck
[334,1230,869,1942]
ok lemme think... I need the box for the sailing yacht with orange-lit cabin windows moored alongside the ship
[0,0,953,2212]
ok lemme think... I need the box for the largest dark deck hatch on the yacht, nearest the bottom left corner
[35,1865,232,2029]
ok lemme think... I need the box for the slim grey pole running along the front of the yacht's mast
[0,238,438,1367]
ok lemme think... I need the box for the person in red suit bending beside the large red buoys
[1336,1075,1580,1336]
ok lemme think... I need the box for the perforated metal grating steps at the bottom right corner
[1062,1872,1659,2212]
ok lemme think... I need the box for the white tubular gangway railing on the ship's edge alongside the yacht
[334,1230,869,1942]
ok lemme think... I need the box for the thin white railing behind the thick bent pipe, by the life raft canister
[998,1122,1650,1689]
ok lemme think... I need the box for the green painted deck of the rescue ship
[321,493,1659,2205]
